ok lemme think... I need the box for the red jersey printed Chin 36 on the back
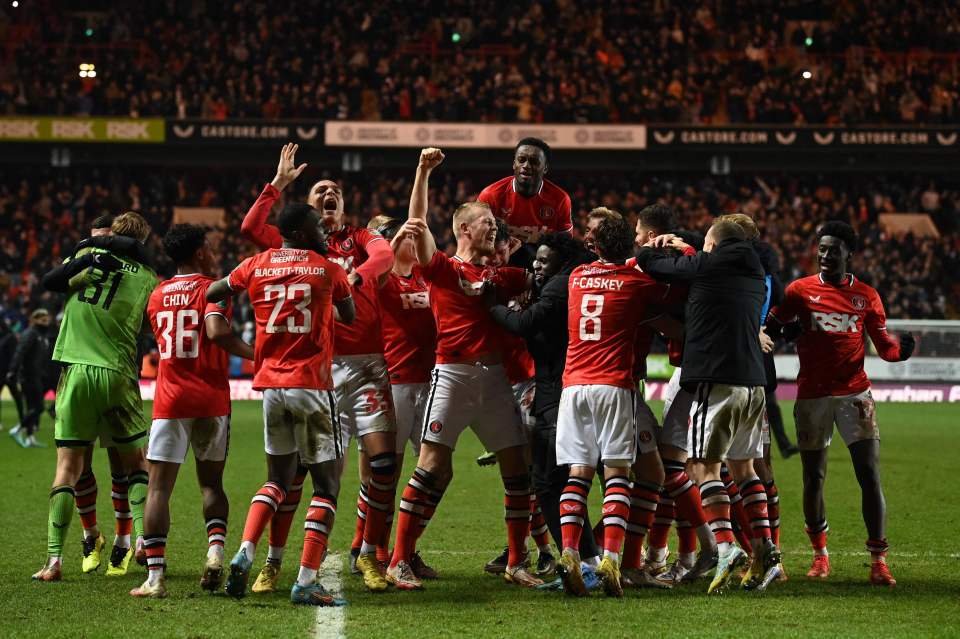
[147,273,230,419]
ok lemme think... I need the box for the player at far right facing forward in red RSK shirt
[769,222,914,586]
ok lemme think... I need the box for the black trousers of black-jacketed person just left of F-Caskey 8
[530,422,600,559]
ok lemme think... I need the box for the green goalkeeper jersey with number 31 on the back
[53,249,157,379]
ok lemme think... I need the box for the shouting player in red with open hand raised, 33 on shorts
[241,144,398,592]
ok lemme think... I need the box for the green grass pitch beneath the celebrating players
[0,402,960,639]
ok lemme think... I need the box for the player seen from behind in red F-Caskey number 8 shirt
[557,216,669,597]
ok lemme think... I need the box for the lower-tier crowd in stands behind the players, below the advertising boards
[0,168,960,336]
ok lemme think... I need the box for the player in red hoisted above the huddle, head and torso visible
[477,138,573,263]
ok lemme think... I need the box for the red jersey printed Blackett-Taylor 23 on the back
[228,249,351,390]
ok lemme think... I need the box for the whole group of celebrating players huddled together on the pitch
[34,138,913,605]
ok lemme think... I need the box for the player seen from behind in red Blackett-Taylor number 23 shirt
[207,203,355,605]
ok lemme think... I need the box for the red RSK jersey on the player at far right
[771,275,900,399]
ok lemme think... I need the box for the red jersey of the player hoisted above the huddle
[477,176,573,241]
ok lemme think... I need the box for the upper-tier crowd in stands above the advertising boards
[0,0,960,124]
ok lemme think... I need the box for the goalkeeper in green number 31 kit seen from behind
[33,213,157,581]
